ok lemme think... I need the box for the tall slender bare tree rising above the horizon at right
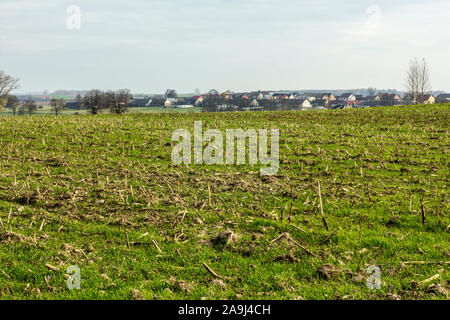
[406,58,431,104]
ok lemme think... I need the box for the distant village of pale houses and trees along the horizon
[14,89,450,112]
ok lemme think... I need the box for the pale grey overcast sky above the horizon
[0,0,450,93]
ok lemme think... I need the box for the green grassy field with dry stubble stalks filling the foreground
[0,105,450,299]
